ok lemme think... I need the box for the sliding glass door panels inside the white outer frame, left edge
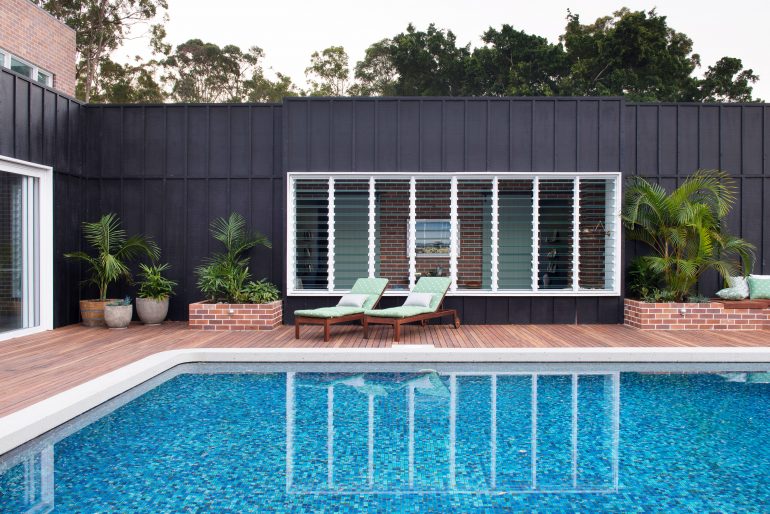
[0,172,40,332]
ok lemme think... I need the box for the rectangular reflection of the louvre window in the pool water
[286,372,620,494]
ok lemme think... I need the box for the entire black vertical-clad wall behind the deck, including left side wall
[0,82,770,326]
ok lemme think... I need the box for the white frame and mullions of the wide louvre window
[286,172,622,297]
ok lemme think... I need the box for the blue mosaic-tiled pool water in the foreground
[0,366,770,513]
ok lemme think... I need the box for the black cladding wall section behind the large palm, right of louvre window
[624,103,770,295]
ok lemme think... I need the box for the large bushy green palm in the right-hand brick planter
[622,170,754,301]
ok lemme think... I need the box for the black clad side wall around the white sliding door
[0,68,86,326]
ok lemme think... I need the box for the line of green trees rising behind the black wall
[33,5,761,103]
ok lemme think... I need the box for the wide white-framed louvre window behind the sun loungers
[287,173,620,296]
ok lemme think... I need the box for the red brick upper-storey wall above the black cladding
[0,0,76,96]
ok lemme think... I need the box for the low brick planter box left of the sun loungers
[188,300,283,330]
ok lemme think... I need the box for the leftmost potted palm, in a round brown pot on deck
[64,213,160,327]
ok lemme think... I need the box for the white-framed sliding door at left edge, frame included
[0,157,53,340]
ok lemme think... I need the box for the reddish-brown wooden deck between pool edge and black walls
[0,323,770,416]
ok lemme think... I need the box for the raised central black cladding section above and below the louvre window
[284,98,626,323]
